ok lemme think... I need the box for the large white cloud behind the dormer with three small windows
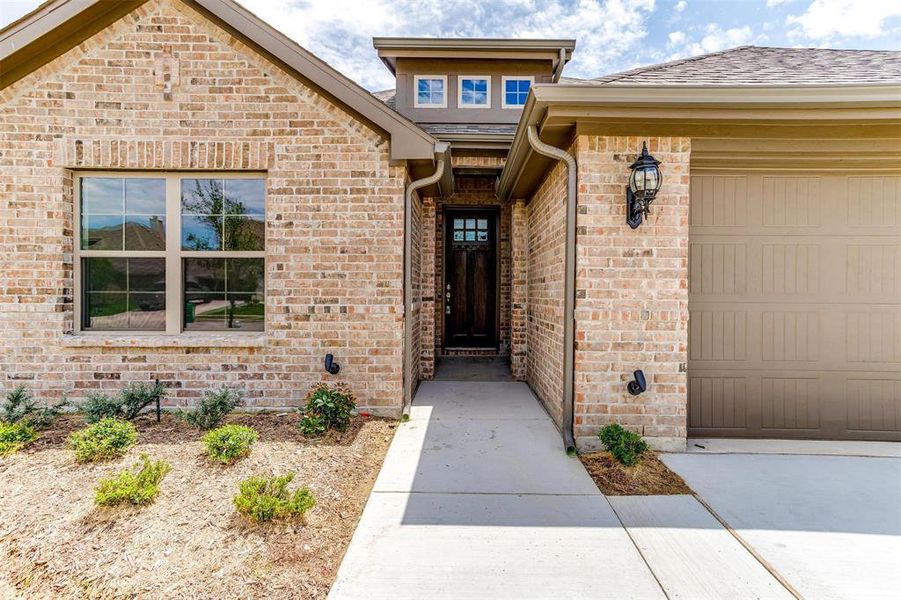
[237,0,655,90]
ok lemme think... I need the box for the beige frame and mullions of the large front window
[72,171,269,336]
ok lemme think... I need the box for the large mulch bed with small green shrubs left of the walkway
[0,413,397,599]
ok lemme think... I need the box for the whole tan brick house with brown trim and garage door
[0,0,901,448]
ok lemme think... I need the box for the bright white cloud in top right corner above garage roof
[786,0,901,41]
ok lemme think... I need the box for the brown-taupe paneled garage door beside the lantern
[688,170,901,440]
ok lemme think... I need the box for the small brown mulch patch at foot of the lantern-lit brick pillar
[579,452,692,496]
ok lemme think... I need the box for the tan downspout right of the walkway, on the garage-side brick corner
[528,125,577,454]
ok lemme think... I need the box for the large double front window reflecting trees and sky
[76,174,266,333]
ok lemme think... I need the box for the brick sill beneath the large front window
[61,332,267,348]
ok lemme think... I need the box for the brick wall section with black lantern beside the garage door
[572,136,691,449]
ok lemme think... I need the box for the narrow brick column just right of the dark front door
[510,200,529,381]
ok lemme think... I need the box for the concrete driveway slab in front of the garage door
[662,452,901,599]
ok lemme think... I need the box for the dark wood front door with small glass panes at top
[444,210,497,348]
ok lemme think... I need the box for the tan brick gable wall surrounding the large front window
[0,0,405,414]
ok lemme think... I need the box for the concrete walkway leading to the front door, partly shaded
[329,381,664,600]
